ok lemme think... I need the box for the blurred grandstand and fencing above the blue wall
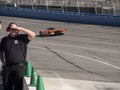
[0,0,120,16]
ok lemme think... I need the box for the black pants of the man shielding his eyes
[3,64,26,90]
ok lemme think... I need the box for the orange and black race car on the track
[39,27,67,36]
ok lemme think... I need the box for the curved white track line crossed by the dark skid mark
[31,46,120,70]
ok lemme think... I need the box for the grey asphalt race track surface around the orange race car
[0,16,120,90]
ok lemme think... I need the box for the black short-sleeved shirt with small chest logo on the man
[0,34,29,65]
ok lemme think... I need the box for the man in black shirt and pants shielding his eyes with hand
[0,22,35,90]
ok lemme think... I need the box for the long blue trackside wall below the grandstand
[0,7,120,27]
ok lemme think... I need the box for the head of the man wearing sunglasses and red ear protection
[7,22,19,37]
